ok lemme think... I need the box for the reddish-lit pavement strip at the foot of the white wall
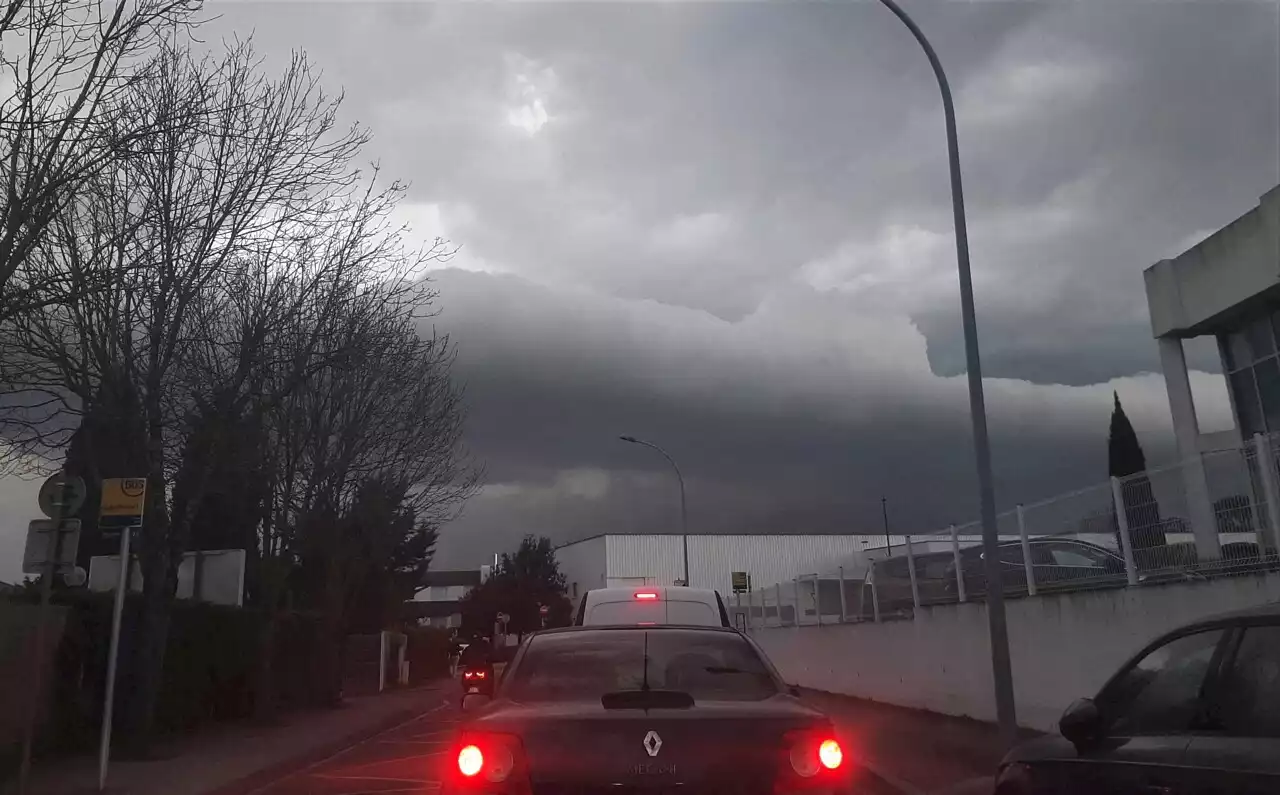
[804,689,1037,795]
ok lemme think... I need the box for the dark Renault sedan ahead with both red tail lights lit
[444,626,855,795]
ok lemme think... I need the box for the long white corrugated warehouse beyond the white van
[556,534,885,602]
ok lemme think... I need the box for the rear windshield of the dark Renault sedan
[503,630,778,702]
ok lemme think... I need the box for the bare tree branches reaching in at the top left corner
[0,0,200,317]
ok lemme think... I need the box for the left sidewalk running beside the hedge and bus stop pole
[0,681,452,795]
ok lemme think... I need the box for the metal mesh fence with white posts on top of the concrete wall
[735,434,1280,627]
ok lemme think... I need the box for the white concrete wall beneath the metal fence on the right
[753,574,1280,731]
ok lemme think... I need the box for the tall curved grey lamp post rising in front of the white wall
[881,0,1018,745]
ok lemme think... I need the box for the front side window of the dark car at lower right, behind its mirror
[1100,630,1222,736]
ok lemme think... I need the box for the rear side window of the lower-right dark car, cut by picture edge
[1217,626,1280,737]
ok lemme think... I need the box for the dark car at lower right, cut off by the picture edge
[996,604,1280,795]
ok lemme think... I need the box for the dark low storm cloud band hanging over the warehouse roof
[424,270,1228,562]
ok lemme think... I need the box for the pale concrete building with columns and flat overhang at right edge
[1143,187,1280,558]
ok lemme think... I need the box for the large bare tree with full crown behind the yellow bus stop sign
[5,35,409,741]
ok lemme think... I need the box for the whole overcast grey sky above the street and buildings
[0,0,1280,579]
